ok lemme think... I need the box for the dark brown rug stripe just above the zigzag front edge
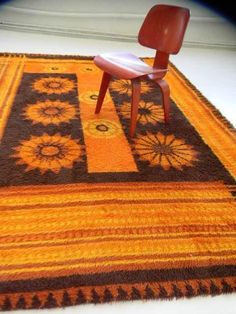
[1,265,236,293]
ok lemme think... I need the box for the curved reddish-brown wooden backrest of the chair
[138,4,190,54]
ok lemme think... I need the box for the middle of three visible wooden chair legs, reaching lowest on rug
[130,79,141,137]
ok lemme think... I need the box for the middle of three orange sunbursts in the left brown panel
[23,100,77,126]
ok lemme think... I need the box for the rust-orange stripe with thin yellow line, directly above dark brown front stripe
[0,251,236,281]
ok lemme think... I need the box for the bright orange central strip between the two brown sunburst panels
[78,68,138,173]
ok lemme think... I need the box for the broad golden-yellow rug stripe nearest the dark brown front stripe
[1,236,236,267]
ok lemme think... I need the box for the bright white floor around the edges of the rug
[0,30,236,314]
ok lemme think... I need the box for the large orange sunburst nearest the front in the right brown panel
[134,132,198,170]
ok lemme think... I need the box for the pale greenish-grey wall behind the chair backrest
[0,0,236,49]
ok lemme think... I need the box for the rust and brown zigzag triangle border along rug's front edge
[0,278,236,311]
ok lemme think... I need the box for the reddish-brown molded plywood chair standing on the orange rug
[94,4,190,137]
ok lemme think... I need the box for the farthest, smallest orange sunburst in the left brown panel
[32,76,75,94]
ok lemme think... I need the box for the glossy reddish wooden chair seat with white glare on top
[94,52,167,80]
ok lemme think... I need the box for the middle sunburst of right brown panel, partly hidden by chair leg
[119,100,164,124]
